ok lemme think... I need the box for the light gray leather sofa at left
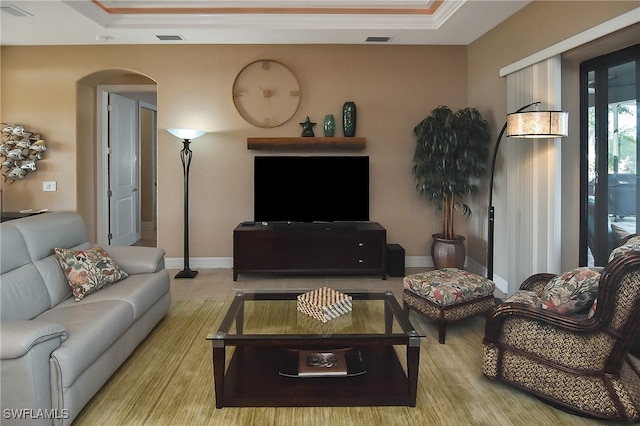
[0,212,170,425]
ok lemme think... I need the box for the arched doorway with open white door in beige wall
[77,70,157,245]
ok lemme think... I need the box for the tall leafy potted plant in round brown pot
[412,106,490,269]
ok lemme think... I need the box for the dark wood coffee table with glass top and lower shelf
[207,290,424,408]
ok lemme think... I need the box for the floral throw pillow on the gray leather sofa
[54,247,129,302]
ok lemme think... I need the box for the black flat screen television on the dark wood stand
[254,156,369,222]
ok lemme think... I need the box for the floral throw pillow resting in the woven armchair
[541,267,602,314]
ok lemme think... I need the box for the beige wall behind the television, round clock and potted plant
[0,1,637,272]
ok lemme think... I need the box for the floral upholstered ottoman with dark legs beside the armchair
[402,268,495,343]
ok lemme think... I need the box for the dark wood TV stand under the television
[233,222,387,281]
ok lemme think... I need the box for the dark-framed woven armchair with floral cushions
[483,234,640,422]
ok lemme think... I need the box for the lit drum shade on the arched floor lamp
[507,111,569,138]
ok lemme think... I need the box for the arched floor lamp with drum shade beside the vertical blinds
[487,102,569,280]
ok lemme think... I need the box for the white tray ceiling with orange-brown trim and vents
[0,0,529,46]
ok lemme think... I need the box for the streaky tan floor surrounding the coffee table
[74,269,632,426]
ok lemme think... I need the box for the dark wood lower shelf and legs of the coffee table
[213,345,420,408]
